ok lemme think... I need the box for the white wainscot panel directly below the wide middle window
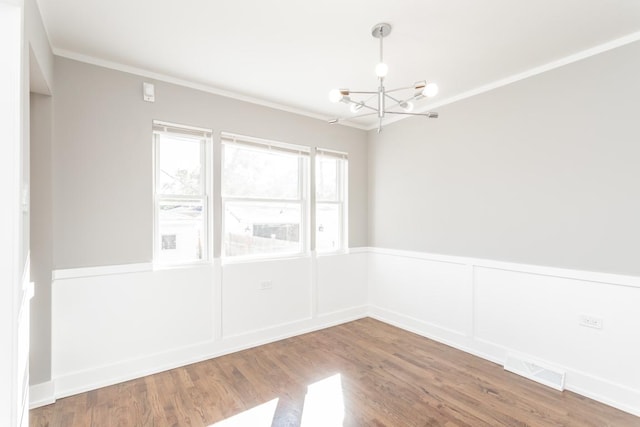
[222,258,311,338]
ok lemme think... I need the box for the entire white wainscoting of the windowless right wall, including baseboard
[368,248,640,415]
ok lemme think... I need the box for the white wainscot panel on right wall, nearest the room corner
[369,253,473,335]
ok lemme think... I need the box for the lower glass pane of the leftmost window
[158,200,206,263]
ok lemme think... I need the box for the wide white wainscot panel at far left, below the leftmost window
[52,266,213,378]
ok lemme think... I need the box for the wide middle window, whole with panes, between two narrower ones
[222,134,309,257]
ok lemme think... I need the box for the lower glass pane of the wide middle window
[224,202,302,256]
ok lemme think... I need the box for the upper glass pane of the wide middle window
[222,144,300,199]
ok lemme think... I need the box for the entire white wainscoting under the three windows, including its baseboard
[42,250,367,407]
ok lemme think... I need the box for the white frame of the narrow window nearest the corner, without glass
[313,147,349,256]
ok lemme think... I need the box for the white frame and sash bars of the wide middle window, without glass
[220,132,311,264]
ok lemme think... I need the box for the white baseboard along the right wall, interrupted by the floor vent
[369,306,640,416]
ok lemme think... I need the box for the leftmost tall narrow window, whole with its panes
[153,121,211,264]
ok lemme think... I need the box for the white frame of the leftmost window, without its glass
[152,120,214,269]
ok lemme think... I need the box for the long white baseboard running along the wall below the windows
[50,306,368,403]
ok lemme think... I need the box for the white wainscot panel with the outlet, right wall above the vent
[475,268,640,395]
